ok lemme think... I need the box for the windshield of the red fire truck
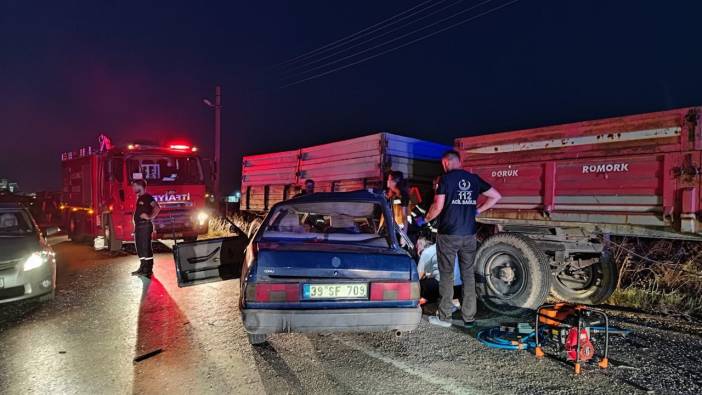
[127,155,203,185]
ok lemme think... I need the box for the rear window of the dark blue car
[262,202,390,248]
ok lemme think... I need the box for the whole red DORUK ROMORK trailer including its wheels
[455,108,702,312]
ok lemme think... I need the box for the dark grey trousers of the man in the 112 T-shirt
[436,234,477,321]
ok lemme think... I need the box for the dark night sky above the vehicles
[0,0,702,192]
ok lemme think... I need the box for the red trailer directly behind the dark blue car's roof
[241,133,451,212]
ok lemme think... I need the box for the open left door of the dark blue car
[173,226,249,288]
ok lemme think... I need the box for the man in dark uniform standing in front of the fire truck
[132,180,161,278]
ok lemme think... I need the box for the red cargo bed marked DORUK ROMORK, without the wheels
[455,108,702,238]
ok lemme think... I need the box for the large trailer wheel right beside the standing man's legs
[475,233,551,316]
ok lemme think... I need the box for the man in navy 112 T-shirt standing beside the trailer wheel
[426,150,502,328]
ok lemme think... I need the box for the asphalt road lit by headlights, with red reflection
[0,243,702,394]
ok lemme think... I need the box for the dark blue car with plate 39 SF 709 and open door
[174,191,421,344]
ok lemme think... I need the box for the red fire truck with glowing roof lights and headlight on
[59,136,209,250]
